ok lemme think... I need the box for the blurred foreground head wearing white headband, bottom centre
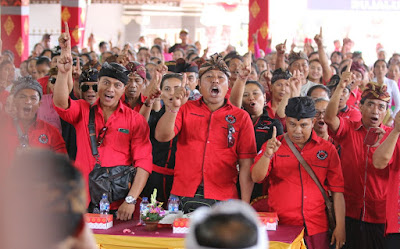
[186,200,268,249]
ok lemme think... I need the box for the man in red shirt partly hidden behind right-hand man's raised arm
[328,76,361,122]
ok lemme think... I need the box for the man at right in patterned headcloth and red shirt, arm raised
[324,64,391,249]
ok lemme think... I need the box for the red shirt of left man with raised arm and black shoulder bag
[54,99,153,205]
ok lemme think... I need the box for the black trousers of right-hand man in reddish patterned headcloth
[343,217,386,249]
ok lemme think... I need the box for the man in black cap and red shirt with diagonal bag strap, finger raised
[251,97,345,249]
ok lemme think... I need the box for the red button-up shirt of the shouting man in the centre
[171,98,257,200]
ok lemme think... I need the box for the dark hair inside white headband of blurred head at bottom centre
[194,213,258,248]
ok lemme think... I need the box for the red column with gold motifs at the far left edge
[1,0,29,67]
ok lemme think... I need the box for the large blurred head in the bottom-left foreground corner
[0,149,96,249]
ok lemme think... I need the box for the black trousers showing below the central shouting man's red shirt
[179,186,219,214]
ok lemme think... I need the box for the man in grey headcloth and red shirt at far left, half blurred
[0,76,67,163]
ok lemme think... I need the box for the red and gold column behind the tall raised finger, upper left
[61,6,86,48]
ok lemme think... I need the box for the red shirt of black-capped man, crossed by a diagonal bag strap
[252,132,344,236]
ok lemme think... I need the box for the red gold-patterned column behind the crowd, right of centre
[248,0,269,52]
